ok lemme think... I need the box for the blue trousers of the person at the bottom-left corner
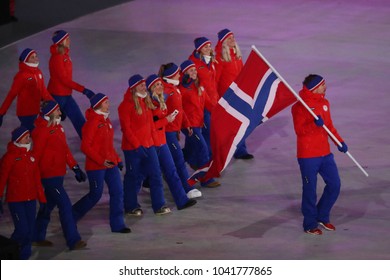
[8,200,37,260]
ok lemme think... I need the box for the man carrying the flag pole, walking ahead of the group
[291,74,348,235]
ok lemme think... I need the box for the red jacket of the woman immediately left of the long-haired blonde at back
[189,51,219,106]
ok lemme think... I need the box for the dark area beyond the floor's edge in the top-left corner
[0,0,131,48]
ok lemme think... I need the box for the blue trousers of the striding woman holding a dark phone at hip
[72,166,126,232]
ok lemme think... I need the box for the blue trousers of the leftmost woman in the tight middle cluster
[123,146,165,212]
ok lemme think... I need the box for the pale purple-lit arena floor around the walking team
[0,0,390,260]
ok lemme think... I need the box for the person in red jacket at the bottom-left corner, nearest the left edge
[0,127,46,260]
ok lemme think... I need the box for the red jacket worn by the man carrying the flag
[291,88,344,158]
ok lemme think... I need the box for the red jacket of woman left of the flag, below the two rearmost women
[179,79,213,127]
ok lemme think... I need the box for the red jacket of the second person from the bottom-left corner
[32,117,77,178]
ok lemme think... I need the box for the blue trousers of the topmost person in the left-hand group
[53,94,85,139]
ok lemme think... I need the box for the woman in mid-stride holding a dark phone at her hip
[73,93,131,233]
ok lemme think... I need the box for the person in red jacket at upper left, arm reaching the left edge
[0,49,53,131]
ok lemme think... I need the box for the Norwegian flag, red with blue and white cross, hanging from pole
[188,47,297,185]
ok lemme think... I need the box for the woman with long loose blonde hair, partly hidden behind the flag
[215,29,253,159]
